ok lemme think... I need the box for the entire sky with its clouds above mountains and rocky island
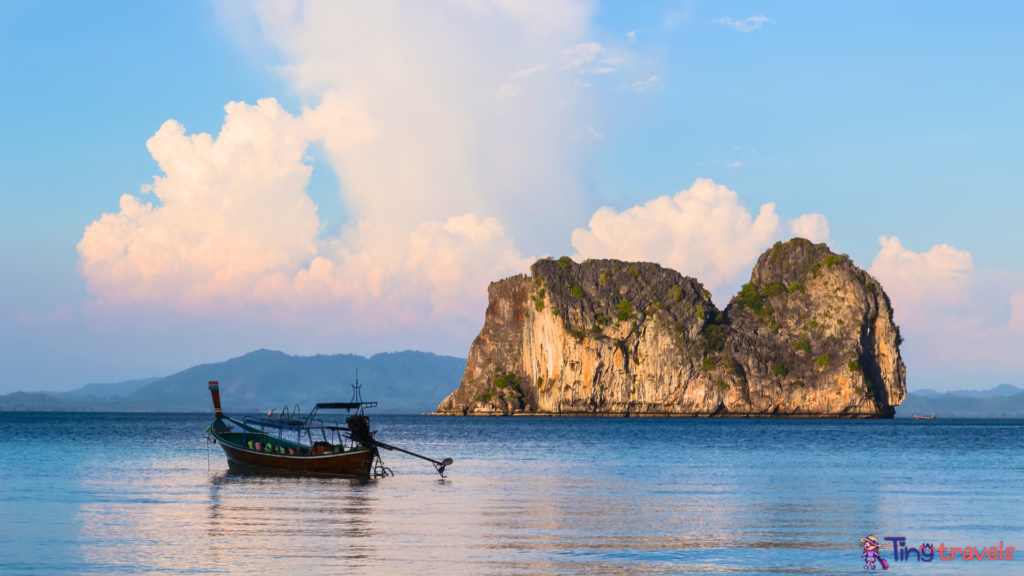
[0,0,1024,393]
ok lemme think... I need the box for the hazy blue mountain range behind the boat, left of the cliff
[0,349,466,414]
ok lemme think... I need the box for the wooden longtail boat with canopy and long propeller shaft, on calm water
[207,377,453,478]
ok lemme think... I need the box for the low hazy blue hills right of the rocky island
[896,384,1024,418]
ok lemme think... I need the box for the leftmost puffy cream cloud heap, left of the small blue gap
[78,98,319,301]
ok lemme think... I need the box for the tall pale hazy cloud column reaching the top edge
[250,0,603,260]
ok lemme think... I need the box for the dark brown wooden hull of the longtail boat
[214,435,374,478]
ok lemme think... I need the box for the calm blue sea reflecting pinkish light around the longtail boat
[0,413,1024,574]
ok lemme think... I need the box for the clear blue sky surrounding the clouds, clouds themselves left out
[0,1,1024,393]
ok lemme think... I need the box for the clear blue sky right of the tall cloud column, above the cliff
[593,2,1024,270]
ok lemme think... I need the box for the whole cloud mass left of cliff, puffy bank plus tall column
[78,0,603,330]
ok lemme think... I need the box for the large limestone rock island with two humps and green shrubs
[437,238,906,417]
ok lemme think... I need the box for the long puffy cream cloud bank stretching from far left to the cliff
[78,99,531,324]
